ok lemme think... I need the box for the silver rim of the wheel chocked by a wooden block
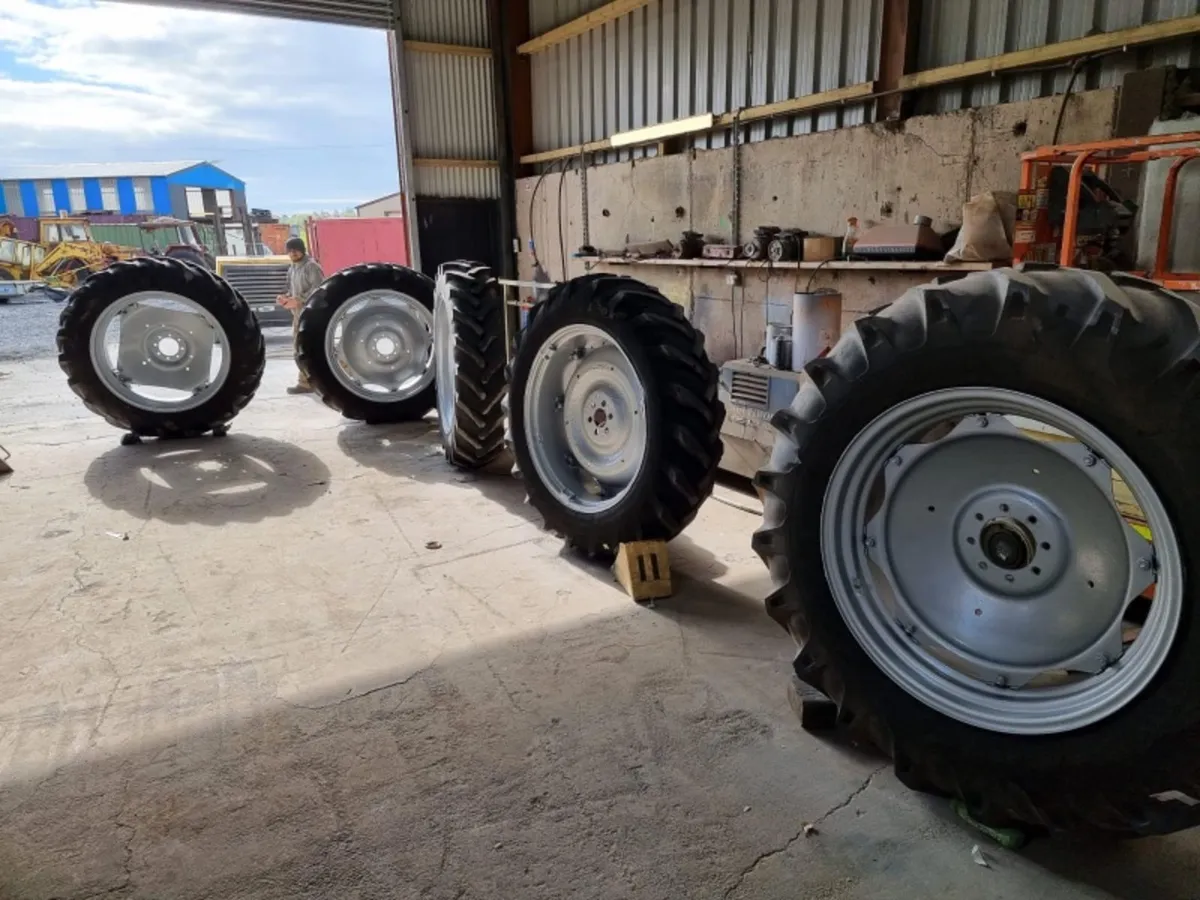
[524,325,647,515]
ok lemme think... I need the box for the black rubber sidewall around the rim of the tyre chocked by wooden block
[509,304,665,550]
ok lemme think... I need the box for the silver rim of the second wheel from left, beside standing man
[325,290,434,403]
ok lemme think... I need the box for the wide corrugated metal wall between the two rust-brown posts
[529,0,888,164]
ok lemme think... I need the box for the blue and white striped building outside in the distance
[0,162,246,221]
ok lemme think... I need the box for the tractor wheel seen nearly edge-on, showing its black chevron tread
[433,260,508,469]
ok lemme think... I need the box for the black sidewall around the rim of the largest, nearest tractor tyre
[785,340,1200,798]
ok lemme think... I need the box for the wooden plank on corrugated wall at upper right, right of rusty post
[898,16,1200,90]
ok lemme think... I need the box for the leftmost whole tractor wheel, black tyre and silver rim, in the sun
[58,258,266,438]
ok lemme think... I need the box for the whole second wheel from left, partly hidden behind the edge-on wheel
[296,263,437,425]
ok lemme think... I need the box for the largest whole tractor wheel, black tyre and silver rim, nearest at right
[755,266,1200,834]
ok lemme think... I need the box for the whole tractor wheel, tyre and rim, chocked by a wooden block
[509,275,725,553]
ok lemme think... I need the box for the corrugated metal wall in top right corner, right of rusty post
[918,0,1200,112]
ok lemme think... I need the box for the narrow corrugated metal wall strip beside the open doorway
[401,0,500,198]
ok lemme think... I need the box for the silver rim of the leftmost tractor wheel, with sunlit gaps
[90,290,230,413]
